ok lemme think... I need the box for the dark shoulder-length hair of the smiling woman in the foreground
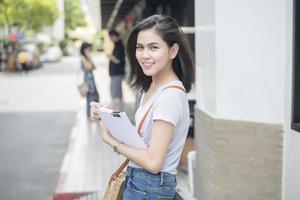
[126,15,195,92]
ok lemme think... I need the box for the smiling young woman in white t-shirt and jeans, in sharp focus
[91,15,194,200]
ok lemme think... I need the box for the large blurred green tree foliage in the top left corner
[0,0,58,32]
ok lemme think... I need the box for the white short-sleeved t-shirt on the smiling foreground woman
[129,81,190,174]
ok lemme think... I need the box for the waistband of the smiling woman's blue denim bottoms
[126,166,176,185]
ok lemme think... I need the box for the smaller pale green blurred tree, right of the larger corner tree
[64,0,86,32]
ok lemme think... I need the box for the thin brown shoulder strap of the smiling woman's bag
[109,85,186,184]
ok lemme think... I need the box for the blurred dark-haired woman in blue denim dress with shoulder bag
[80,42,99,121]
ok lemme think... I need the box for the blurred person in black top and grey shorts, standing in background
[108,30,125,110]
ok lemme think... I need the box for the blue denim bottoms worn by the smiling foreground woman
[123,166,177,200]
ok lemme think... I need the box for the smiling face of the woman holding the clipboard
[135,29,173,76]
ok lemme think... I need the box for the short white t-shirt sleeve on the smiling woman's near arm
[153,89,185,126]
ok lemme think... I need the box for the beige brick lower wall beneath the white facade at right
[194,108,283,200]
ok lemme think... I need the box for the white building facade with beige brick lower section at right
[194,0,300,200]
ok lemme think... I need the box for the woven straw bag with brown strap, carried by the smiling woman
[103,86,185,200]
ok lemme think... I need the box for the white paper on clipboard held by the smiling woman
[97,107,147,149]
